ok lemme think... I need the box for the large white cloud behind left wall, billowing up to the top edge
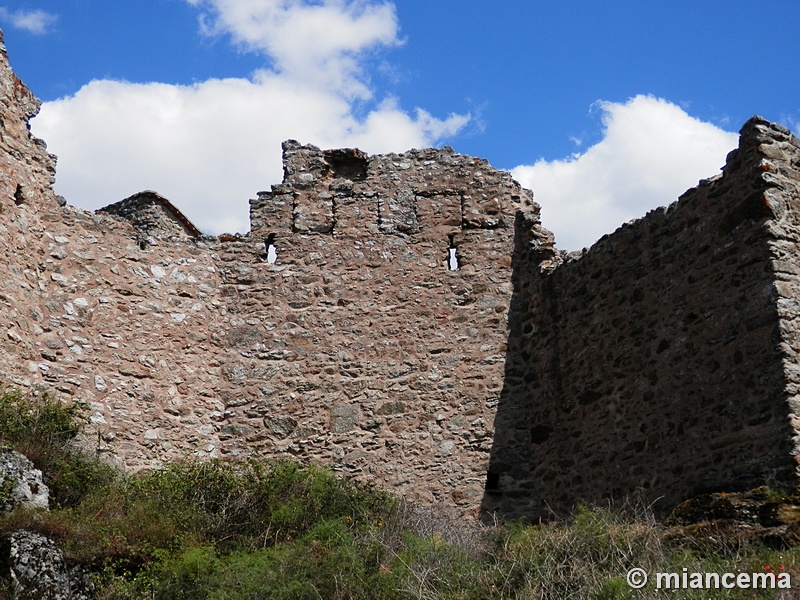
[32,0,469,233]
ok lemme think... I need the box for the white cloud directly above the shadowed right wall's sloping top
[511,96,738,250]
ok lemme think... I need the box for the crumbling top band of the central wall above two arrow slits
[250,140,538,239]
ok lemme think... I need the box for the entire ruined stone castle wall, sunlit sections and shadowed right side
[0,28,800,517]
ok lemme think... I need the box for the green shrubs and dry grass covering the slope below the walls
[0,386,800,600]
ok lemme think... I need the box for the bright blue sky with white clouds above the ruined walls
[0,0,800,249]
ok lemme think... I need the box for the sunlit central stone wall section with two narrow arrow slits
[212,142,548,511]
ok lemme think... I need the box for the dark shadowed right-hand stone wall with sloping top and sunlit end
[484,118,800,518]
